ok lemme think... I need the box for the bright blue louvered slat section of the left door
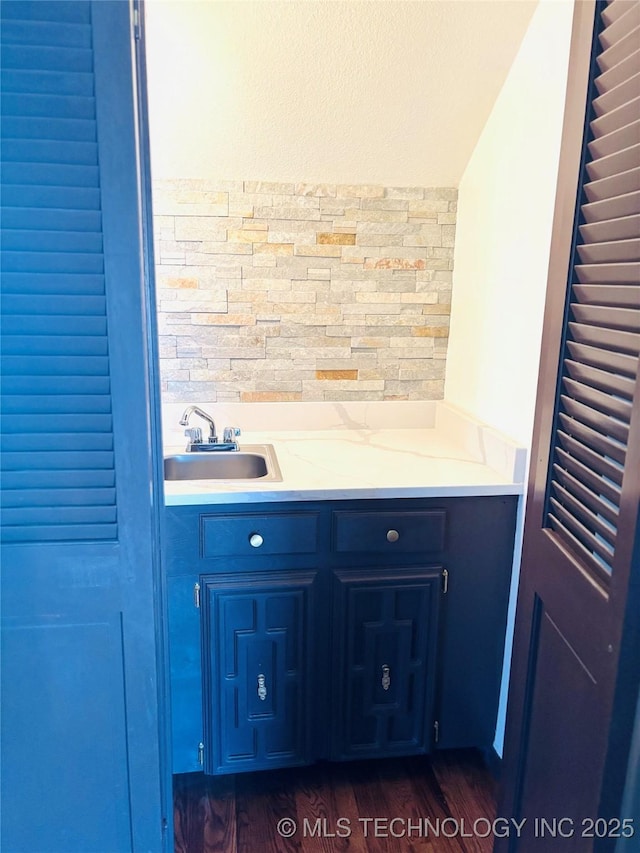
[0,0,117,542]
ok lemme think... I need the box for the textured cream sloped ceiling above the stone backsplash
[146,0,549,186]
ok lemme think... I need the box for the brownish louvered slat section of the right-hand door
[546,0,640,579]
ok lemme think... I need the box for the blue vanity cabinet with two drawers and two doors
[166,496,517,774]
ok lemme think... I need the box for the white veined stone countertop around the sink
[164,402,526,506]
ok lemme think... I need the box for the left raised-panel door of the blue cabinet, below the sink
[203,571,315,773]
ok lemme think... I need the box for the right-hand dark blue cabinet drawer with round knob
[333,509,447,554]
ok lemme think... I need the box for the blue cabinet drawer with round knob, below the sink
[200,512,318,557]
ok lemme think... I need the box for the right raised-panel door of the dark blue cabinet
[332,568,441,759]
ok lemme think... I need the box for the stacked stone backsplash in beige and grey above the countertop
[153,180,457,402]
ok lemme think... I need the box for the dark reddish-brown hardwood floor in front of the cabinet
[174,750,496,853]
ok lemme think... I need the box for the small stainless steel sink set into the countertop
[164,444,282,482]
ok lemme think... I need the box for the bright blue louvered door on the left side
[1,0,162,853]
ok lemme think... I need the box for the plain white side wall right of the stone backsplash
[445,0,573,754]
